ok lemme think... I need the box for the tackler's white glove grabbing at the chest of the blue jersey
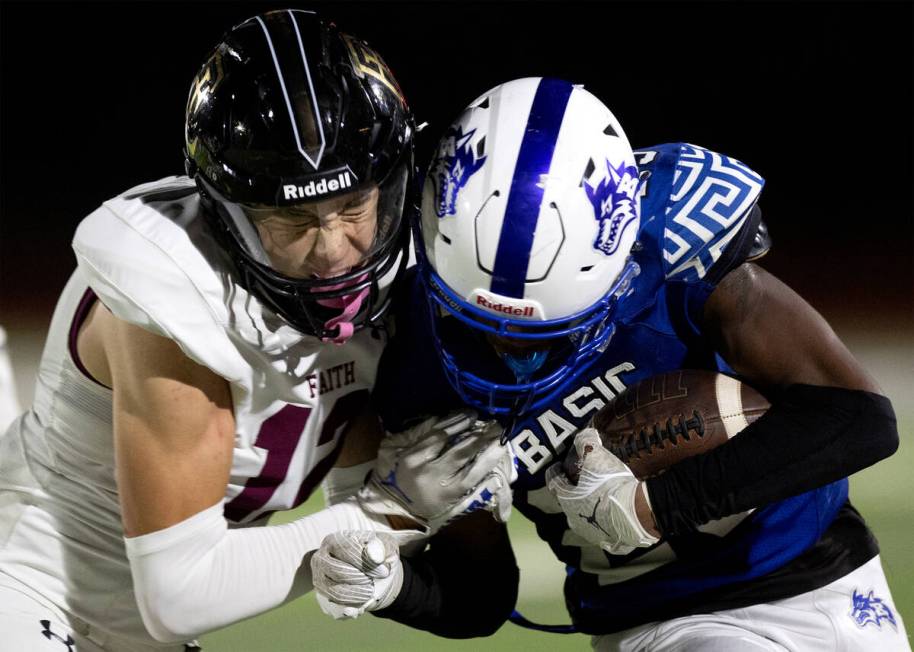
[358,409,517,536]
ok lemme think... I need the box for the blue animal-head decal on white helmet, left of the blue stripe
[428,126,486,217]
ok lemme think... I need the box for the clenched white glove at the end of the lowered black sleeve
[311,531,403,620]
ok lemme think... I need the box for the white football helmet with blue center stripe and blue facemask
[416,78,640,414]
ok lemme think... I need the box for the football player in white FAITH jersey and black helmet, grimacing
[0,10,512,652]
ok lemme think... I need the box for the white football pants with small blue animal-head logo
[591,555,911,652]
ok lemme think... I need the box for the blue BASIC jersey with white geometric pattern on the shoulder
[375,143,864,633]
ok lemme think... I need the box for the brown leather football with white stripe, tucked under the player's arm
[564,369,770,482]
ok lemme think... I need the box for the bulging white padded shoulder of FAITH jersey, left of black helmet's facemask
[73,177,320,388]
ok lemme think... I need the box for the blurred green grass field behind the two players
[10,328,914,652]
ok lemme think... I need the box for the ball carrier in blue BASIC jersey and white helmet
[315,78,910,652]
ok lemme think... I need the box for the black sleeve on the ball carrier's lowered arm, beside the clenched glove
[373,530,520,638]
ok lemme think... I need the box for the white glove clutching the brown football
[546,428,659,555]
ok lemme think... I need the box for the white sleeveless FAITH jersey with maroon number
[0,177,383,645]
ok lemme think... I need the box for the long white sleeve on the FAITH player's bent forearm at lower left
[124,499,409,643]
